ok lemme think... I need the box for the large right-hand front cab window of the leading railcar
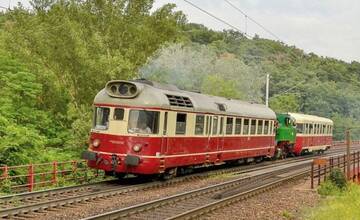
[128,110,160,134]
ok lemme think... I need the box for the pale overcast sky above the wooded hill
[0,0,360,62]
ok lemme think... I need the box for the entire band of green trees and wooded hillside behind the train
[0,0,360,165]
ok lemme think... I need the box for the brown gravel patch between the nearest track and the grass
[202,179,320,220]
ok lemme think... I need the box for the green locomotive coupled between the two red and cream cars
[275,113,296,158]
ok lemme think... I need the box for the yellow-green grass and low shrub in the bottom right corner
[306,181,360,220]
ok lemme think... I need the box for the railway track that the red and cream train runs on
[0,146,354,218]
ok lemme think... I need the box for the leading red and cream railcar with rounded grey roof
[82,80,332,176]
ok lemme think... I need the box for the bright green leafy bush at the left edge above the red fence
[0,54,49,165]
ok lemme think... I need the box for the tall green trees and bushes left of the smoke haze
[0,0,186,165]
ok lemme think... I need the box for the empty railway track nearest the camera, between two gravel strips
[82,161,309,220]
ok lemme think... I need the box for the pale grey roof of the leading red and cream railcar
[94,80,276,119]
